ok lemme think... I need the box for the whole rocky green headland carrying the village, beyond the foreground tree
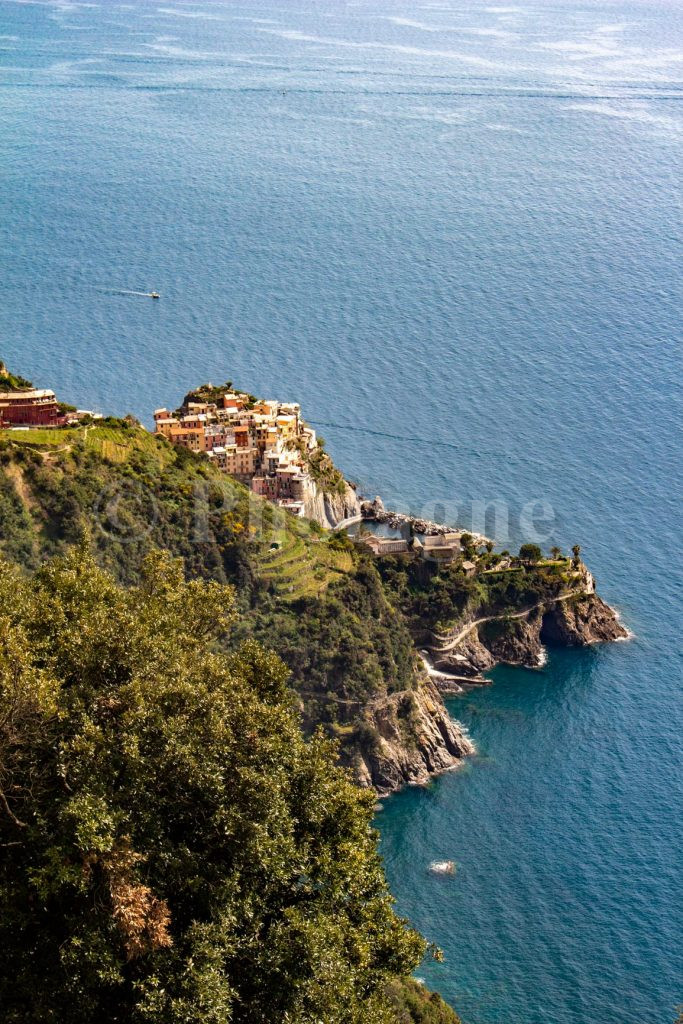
[0,371,627,795]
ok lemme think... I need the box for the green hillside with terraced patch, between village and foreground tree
[0,420,415,731]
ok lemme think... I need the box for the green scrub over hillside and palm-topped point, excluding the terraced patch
[0,428,581,745]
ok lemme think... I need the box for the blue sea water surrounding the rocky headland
[0,0,683,1024]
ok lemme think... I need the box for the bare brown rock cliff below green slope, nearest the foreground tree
[347,679,474,796]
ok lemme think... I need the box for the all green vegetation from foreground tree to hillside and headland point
[0,385,593,1024]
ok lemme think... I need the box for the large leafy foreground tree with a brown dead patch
[0,551,428,1024]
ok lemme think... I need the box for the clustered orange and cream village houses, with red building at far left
[0,361,485,574]
